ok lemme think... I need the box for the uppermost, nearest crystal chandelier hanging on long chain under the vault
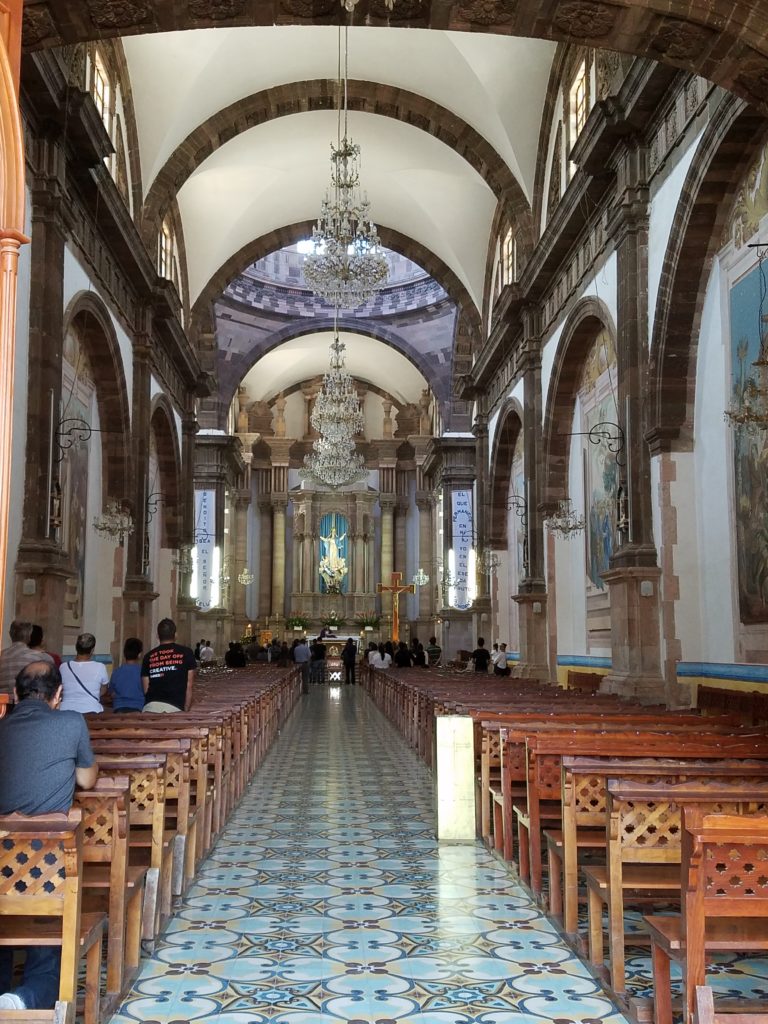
[304,26,389,309]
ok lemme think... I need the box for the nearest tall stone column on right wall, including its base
[602,138,668,703]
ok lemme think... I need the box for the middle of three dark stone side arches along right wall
[542,296,616,505]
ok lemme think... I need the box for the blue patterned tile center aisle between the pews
[112,686,625,1024]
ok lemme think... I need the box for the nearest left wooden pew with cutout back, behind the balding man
[0,810,106,1024]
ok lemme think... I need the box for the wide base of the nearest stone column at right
[600,565,669,703]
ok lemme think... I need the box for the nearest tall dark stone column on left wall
[12,145,68,650]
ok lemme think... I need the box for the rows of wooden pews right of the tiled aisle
[367,670,768,1024]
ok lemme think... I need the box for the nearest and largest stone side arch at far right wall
[646,96,768,451]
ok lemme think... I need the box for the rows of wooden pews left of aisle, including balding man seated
[0,618,300,1024]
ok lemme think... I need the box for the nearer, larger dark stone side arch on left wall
[63,292,135,512]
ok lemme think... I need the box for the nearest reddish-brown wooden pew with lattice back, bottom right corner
[645,806,768,1024]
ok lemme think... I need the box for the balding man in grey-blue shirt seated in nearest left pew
[0,662,98,1011]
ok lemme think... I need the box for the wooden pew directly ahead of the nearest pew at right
[584,779,768,993]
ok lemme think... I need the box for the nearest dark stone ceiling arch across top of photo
[24,0,768,110]
